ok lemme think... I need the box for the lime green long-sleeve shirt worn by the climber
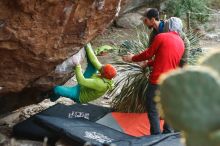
[75,45,114,103]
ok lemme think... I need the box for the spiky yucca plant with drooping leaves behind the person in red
[109,26,204,113]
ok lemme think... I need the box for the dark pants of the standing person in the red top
[146,83,173,135]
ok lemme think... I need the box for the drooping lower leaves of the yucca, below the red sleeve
[111,62,150,113]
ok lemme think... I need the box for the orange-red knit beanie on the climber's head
[102,64,117,80]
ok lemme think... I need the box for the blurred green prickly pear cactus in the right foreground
[159,52,220,146]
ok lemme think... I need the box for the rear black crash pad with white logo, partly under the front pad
[13,104,111,141]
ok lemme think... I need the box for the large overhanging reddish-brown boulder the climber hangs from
[0,0,124,114]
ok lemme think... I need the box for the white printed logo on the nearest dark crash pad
[84,131,114,143]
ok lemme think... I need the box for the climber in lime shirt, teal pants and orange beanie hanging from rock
[50,44,117,103]
